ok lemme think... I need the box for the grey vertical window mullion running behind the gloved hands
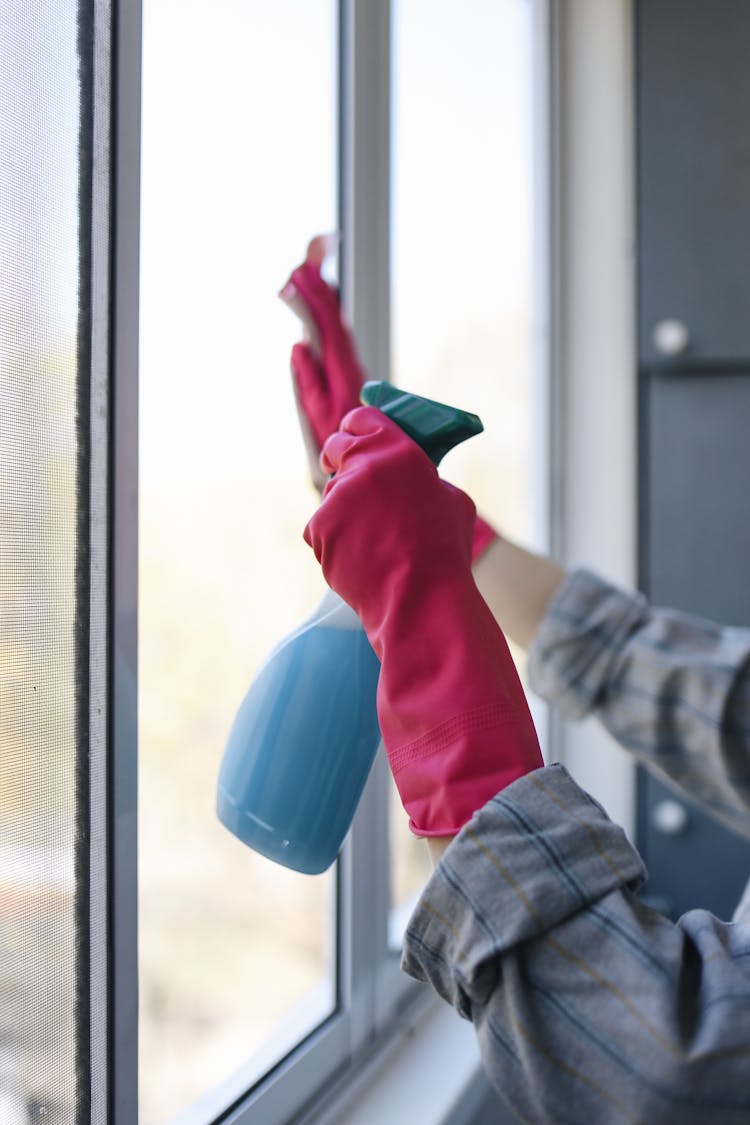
[340,0,390,1051]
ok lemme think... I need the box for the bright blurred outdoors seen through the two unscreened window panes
[138,0,532,1125]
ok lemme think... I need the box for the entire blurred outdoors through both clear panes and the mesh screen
[0,0,534,1125]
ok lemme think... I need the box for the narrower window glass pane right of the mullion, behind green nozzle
[391,0,534,931]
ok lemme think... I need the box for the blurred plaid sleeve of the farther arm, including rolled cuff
[528,570,750,835]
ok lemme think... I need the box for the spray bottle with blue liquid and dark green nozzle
[216,383,482,874]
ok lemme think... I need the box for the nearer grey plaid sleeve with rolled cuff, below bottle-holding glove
[403,766,750,1125]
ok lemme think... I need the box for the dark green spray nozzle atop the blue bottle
[360,381,485,465]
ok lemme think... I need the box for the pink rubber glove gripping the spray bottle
[305,406,543,836]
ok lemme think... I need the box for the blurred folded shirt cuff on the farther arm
[527,569,649,719]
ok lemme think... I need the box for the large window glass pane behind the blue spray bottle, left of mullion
[138,0,337,1125]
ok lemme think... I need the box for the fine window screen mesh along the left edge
[0,0,88,1125]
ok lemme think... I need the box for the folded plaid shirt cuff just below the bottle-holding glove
[401,765,645,1019]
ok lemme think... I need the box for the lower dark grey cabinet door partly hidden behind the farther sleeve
[639,365,750,918]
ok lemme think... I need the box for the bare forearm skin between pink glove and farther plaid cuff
[473,537,566,649]
